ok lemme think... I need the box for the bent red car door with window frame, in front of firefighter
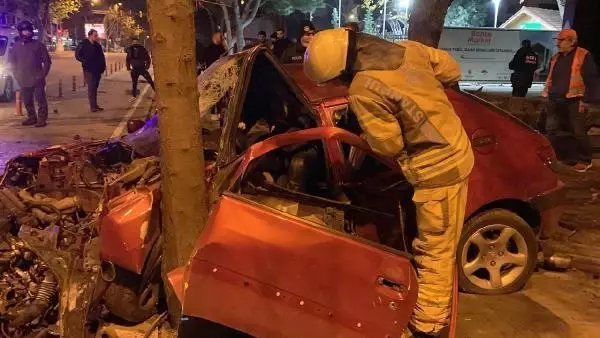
[171,128,417,337]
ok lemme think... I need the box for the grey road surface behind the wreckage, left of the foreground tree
[0,71,154,172]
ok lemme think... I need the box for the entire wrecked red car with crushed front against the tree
[0,48,564,337]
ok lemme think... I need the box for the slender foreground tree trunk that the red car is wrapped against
[148,0,208,328]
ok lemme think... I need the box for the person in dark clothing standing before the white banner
[508,40,539,97]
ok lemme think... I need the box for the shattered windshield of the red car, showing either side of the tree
[122,55,244,156]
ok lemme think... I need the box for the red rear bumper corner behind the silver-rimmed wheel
[529,180,567,239]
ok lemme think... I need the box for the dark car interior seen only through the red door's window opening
[239,141,410,251]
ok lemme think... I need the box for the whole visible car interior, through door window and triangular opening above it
[226,54,418,254]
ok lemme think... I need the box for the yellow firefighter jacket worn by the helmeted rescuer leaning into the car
[349,41,474,188]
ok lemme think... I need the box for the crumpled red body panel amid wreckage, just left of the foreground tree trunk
[100,184,160,274]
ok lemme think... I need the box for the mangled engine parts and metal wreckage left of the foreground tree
[0,135,160,337]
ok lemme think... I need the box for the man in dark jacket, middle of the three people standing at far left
[75,29,106,113]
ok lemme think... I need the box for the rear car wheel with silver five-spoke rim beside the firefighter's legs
[457,209,538,295]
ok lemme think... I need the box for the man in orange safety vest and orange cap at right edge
[542,29,598,172]
